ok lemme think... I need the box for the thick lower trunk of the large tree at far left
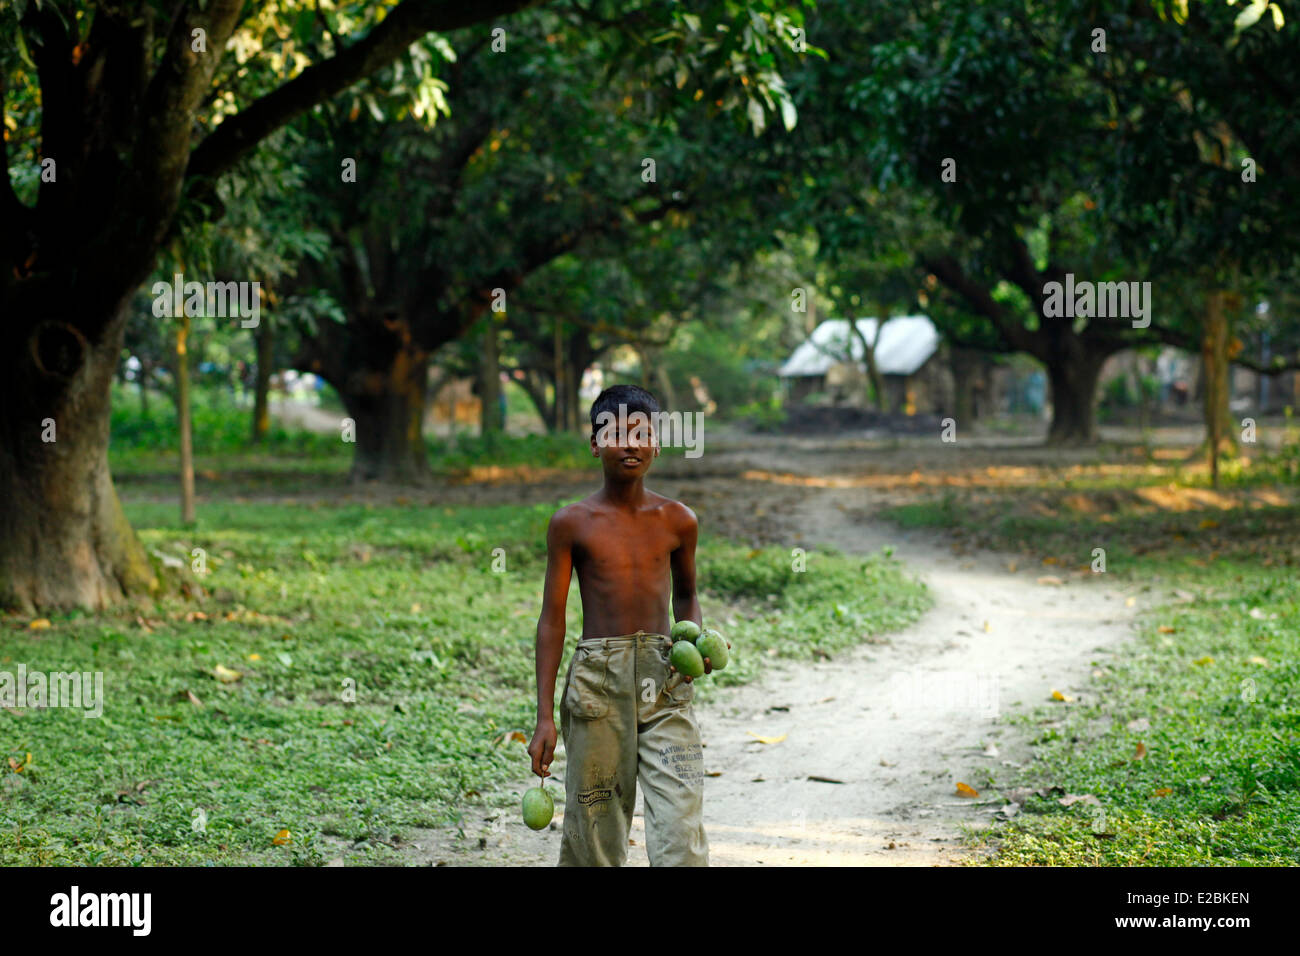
[0,316,159,614]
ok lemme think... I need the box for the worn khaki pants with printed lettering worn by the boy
[559,631,709,866]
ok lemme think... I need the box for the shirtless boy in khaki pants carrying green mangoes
[528,385,712,866]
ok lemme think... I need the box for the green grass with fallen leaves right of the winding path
[889,488,1300,866]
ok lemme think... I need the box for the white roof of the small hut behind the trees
[779,315,939,378]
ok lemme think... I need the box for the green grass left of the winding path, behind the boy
[0,486,928,865]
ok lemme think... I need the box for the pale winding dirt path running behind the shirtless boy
[361,438,1141,866]
